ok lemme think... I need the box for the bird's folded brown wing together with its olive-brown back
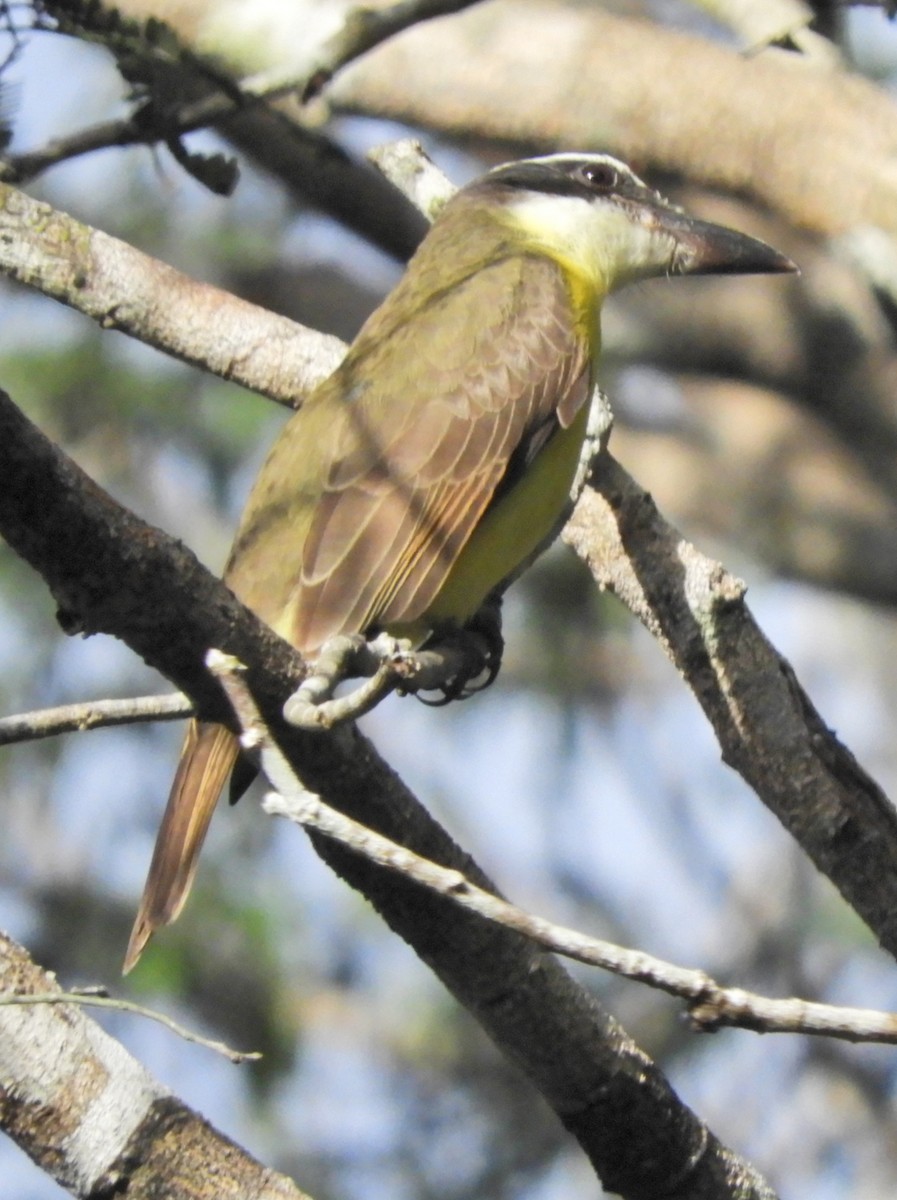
[228,257,588,650]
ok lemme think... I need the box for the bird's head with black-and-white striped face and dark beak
[472,154,796,292]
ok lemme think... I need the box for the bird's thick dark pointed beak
[655,208,797,275]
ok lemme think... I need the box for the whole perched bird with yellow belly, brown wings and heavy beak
[125,152,795,972]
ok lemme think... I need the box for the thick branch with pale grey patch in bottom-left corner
[0,935,307,1200]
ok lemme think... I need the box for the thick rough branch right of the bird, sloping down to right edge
[562,455,897,955]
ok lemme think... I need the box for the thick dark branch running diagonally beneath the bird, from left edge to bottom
[0,386,772,1200]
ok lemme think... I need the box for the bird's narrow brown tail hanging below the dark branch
[125,721,240,974]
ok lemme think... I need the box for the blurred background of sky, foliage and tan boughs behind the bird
[0,0,897,1200]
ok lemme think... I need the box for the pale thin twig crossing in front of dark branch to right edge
[207,650,897,1044]
